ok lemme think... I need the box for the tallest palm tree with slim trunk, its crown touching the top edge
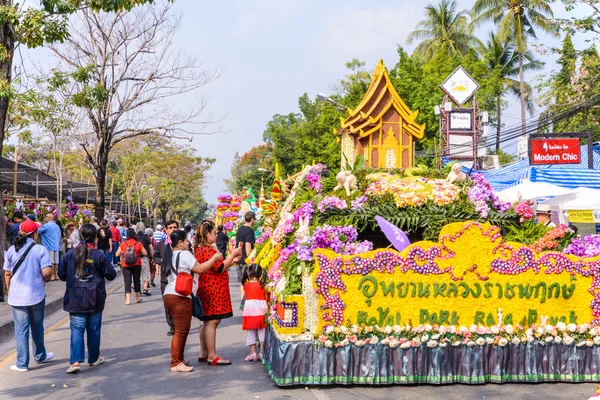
[473,0,554,136]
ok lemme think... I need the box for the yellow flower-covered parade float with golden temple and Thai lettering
[253,61,600,386]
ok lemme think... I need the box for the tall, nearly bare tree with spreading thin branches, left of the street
[51,4,219,217]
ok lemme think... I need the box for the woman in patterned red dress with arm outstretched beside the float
[194,221,242,366]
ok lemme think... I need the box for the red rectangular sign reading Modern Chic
[531,138,581,165]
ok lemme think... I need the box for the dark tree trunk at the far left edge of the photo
[0,0,15,260]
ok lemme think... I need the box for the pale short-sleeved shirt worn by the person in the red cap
[4,238,52,307]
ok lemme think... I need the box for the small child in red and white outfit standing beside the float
[242,264,268,361]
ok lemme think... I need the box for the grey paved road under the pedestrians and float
[0,275,597,400]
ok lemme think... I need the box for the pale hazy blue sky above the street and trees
[21,0,587,203]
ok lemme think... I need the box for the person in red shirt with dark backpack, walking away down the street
[116,228,148,305]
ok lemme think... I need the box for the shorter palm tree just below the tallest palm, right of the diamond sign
[477,33,544,153]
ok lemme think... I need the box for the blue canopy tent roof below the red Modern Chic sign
[444,146,600,191]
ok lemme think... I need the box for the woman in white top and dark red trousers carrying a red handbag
[163,230,223,372]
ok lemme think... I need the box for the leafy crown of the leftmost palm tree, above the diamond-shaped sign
[408,0,473,61]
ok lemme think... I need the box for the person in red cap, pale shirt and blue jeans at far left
[4,219,54,372]
